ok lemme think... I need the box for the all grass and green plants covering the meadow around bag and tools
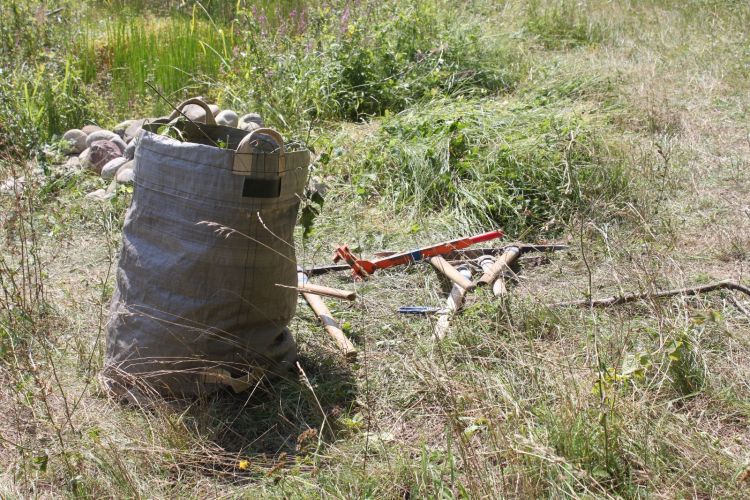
[0,0,750,498]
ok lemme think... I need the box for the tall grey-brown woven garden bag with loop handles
[102,99,310,395]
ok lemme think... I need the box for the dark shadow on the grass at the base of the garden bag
[175,352,356,460]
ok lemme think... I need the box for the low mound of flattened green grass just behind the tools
[321,96,632,234]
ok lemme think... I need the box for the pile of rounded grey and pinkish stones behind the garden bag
[63,104,263,200]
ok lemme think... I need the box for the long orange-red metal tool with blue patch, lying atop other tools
[333,230,504,278]
